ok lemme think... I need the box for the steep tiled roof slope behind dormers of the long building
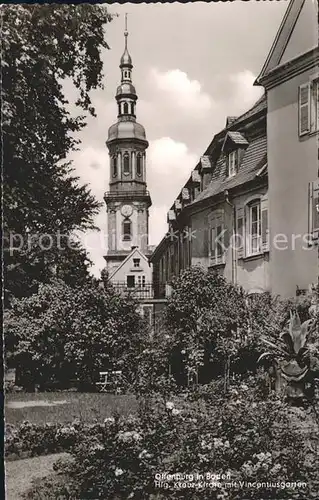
[190,136,267,205]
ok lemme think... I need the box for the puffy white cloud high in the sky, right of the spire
[150,68,213,118]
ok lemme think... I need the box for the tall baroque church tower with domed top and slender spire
[105,18,152,274]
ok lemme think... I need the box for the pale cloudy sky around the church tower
[69,0,288,276]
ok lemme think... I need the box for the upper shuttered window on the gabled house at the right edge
[298,79,319,137]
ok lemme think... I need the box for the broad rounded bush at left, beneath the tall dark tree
[4,280,143,389]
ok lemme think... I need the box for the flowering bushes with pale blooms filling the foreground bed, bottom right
[26,379,319,500]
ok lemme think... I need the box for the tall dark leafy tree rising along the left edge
[1,4,111,296]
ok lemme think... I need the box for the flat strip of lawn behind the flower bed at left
[5,392,137,424]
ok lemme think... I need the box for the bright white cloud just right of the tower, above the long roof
[147,137,198,245]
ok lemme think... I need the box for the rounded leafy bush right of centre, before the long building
[166,267,249,382]
